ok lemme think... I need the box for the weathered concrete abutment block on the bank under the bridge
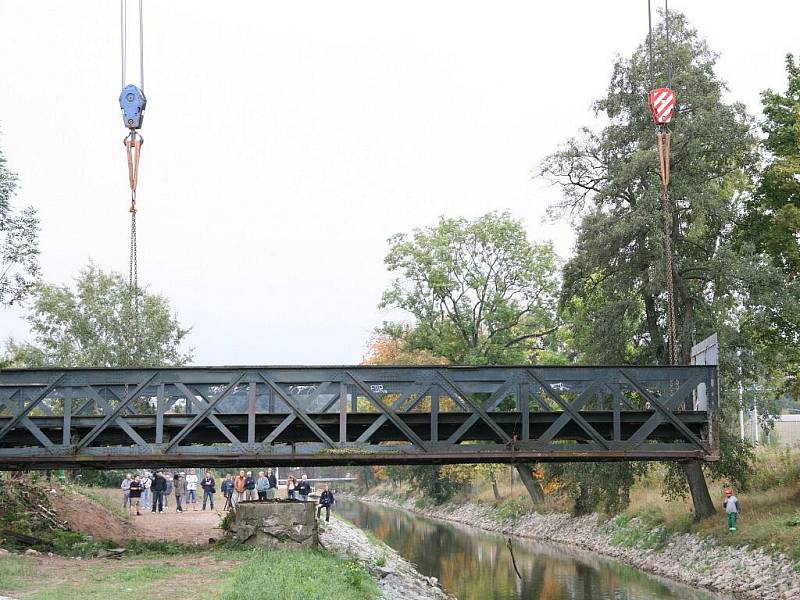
[229,502,319,548]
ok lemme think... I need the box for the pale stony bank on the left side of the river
[320,516,455,600]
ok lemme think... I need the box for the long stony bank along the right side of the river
[360,496,800,600]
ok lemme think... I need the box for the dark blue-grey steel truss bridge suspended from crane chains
[0,366,719,469]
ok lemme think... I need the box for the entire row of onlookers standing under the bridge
[120,469,335,521]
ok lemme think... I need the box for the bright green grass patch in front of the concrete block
[219,550,379,600]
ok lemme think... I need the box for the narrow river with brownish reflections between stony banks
[336,500,720,600]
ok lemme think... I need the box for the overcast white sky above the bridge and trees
[0,0,800,364]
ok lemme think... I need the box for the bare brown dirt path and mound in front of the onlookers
[53,489,224,545]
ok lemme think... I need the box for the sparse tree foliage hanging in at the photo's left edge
[0,136,39,306]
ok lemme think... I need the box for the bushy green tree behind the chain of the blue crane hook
[6,264,191,367]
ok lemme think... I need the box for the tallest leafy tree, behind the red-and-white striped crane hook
[541,12,758,517]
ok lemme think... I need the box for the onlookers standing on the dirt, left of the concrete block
[120,469,217,515]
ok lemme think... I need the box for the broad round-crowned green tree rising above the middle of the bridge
[381,213,558,365]
